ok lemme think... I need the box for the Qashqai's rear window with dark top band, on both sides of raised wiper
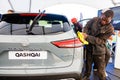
[0,13,71,35]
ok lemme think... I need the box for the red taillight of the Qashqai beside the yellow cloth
[52,38,83,48]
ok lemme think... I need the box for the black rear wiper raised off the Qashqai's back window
[26,10,45,35]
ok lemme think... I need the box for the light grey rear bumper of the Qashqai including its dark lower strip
[0,59,83,80]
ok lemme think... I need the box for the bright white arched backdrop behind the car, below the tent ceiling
[45,4,98,20]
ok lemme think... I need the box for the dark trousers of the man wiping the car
[84,53,106,80]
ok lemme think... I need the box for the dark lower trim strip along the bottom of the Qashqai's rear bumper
[0,73,81,80]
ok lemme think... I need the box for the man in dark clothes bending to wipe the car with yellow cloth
[83,10,114,80]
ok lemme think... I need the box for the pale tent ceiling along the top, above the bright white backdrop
[0,0,119,12]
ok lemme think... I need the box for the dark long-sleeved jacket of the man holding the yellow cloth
[83,17,114,55]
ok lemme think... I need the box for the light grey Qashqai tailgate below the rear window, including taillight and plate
[0,15,82,69]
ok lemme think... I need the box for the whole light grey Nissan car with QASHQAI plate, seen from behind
[0,13,83,80]
